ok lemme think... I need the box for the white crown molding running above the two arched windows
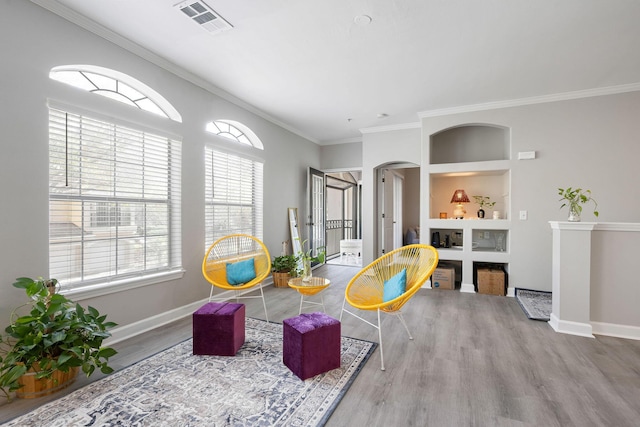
[30,0,319,144]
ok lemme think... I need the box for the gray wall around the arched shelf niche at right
[421,92,640,291]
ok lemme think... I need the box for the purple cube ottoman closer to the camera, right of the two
[282,312,340,380]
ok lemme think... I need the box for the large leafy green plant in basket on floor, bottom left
[0,277,117,400]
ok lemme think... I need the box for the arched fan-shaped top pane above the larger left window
[49,65,182,122]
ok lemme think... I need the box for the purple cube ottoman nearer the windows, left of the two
[193,302,245,356]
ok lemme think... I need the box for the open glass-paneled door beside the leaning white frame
[303,168,326,266]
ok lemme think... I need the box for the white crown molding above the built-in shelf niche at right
[418,83,640,119]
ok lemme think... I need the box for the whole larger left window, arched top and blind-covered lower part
[48,65,183,295]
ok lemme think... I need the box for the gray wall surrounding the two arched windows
[0,1,320,329]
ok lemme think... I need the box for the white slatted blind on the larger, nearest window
[49,108,181,289]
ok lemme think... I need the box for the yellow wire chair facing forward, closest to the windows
[202,234,271,322]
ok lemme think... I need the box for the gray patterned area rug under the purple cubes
[5,318,376,427]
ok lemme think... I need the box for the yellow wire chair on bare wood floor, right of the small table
[340,244,438,371]
